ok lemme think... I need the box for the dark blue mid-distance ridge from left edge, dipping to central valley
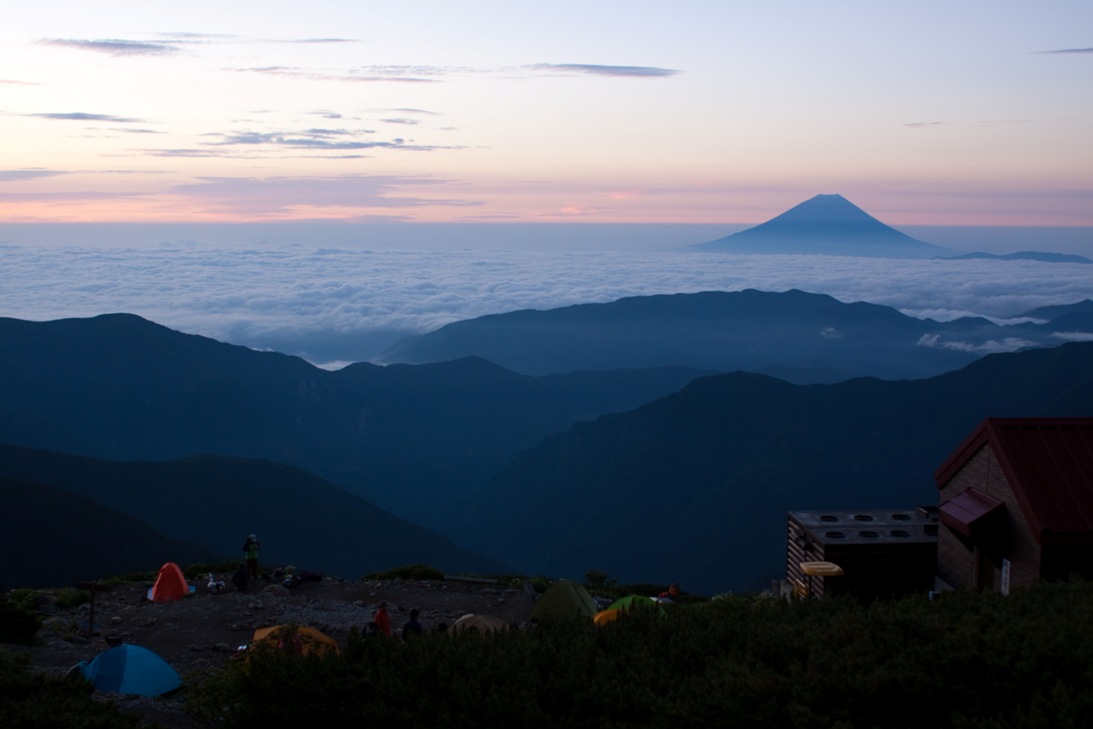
[0,315,704,522]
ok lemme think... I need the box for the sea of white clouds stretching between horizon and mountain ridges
[0,244,1093,367]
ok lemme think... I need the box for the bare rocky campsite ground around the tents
[10,577,534,729]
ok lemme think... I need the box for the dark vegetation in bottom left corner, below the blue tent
[0,648,139,729]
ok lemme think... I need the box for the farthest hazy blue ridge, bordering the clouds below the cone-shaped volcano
[377,290,1093,384]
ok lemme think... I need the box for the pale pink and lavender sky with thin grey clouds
[0,0,1093,228]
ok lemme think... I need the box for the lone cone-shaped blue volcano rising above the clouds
[693,195,957,258]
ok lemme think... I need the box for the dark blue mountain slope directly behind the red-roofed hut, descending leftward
[448,343,1093,595]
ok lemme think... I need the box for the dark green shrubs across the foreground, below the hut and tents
[190,584,1093,729]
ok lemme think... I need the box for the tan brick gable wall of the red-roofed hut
[938,445,1041,589]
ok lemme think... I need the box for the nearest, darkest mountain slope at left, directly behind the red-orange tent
[0,444,505,585]
